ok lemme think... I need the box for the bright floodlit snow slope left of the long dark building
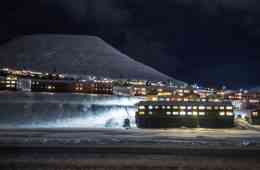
[0,92,142,128]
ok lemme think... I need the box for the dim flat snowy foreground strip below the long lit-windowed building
[0,128,260,170]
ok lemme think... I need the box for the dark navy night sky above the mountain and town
[0,0,260,88]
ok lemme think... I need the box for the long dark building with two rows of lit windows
[136,101,234,128]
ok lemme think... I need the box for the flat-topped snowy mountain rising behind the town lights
[0,34,181,80]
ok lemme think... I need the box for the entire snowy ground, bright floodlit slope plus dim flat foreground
[0,92,260,170]
